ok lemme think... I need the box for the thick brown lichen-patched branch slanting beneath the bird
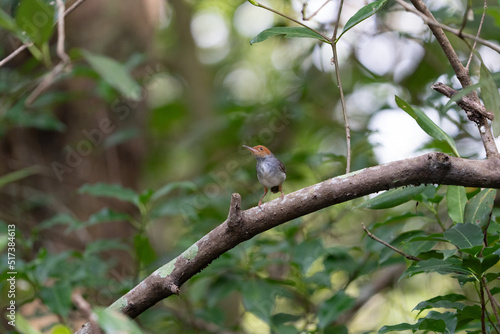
[74,153,500,333]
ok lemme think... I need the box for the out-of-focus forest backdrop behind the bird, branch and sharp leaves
[0,0,500,333]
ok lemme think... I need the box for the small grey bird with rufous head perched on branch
[243,145,286,208]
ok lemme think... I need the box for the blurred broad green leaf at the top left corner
[16,0,55,44]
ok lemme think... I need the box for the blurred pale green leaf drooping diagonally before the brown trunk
[82,50,142,101]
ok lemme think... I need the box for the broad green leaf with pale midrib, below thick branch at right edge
[464,189,497,227]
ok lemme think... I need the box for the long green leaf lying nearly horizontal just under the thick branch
[358,184,427,210]
